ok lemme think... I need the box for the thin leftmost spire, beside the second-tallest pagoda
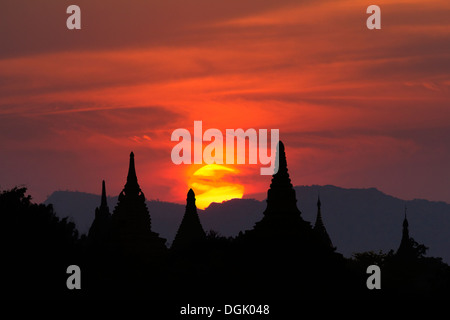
[88,180,111,247]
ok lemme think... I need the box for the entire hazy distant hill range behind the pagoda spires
[45,186,450,263]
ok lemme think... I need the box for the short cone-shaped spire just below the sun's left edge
[171,189,206,250]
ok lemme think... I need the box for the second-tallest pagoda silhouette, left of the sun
[111,152,166,254]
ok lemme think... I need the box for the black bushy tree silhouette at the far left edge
[0,187,81,298]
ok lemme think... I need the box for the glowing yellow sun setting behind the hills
[189,164,244,209]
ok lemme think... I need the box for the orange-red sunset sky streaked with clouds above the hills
[0,0,450,208]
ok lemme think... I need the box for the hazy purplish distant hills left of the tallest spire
[44,191,265,244]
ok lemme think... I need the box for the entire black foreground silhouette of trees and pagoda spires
[0,147,450,300]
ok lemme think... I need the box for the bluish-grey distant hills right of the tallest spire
[295,186,450,263]
